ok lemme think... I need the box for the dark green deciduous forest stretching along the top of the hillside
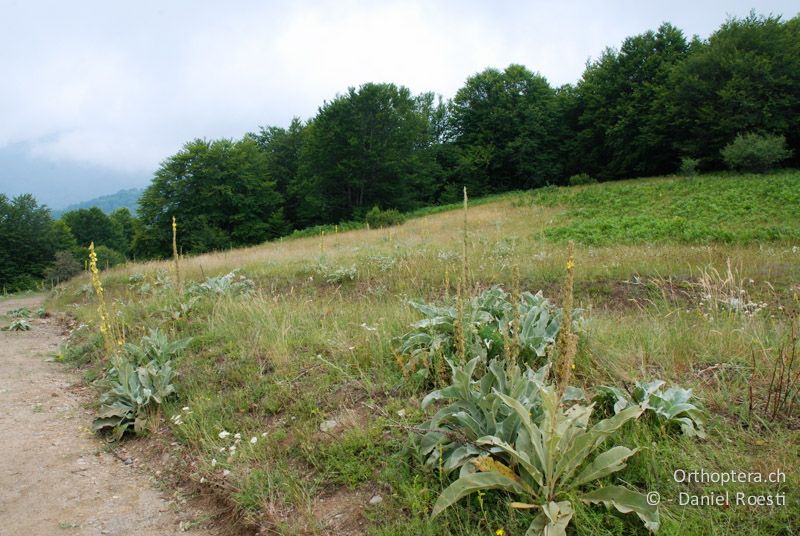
[0,13,800,292]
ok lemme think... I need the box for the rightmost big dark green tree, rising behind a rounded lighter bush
[663,12,800,168]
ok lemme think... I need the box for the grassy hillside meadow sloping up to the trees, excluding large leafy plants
[52,173,800,536]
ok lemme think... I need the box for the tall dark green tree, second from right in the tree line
[569,23,689,179]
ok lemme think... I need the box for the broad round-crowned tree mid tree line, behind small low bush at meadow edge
[298,83,433,223]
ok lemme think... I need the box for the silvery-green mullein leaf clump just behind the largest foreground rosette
[398,286,564,379]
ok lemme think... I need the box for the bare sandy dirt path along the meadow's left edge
[0,297,219,536]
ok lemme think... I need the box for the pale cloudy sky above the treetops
[0,0,800,209]
